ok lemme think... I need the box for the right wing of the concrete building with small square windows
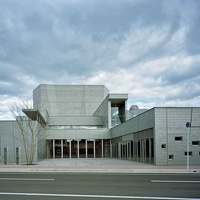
[111,107,200,165]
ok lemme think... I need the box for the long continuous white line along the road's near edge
[0,192,199,200]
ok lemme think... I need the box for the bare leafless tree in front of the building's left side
[10,99,42,165]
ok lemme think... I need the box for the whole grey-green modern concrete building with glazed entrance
[0,84,200,165]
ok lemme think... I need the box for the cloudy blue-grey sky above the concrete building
[0,0,200,120]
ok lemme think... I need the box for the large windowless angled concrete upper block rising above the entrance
[33,84,108,116]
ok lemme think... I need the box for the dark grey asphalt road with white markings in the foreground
[0,173,200,200]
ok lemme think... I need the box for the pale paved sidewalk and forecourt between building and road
[0,158,200,173]
